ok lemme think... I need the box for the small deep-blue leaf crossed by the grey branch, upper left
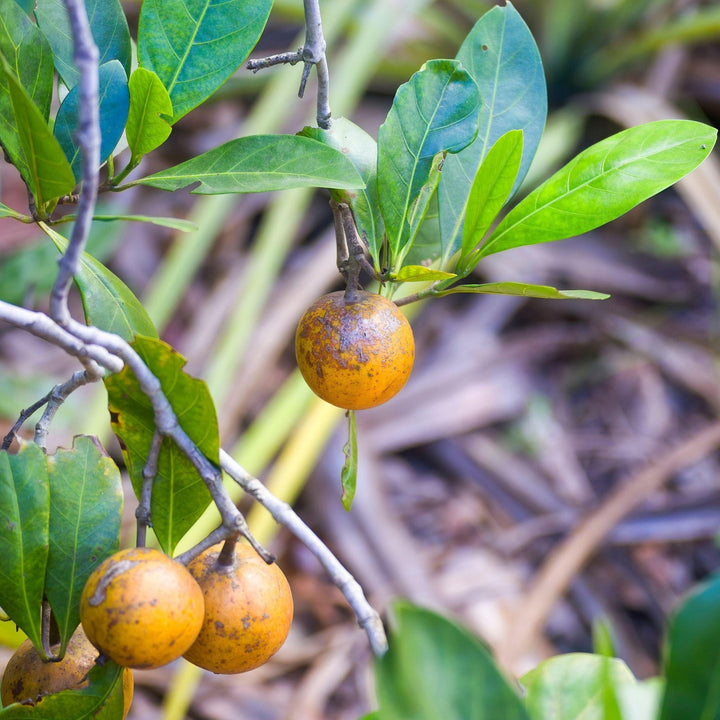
[54,60,130,181]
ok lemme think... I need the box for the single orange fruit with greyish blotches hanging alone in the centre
[295,291,415,410]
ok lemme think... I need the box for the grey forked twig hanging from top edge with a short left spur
[246,0,331,130]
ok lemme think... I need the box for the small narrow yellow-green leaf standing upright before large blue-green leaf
[462,130,523,273]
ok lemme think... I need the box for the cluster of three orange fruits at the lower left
[1,543,293,714]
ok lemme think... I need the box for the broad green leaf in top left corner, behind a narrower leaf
[0,0,53,187]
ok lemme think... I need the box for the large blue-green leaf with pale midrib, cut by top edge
[138,0,272,124]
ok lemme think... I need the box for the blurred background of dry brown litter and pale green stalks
[0,0,720,720]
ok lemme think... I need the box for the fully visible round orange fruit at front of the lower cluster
[80,548,204,668]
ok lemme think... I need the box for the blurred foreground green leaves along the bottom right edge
[363,577,720,720]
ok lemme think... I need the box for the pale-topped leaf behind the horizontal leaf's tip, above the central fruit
[302,118,385,272]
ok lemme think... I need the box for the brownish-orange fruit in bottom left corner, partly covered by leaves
[0,627,133,718]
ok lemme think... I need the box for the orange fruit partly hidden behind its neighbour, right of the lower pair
[184,543,293,674]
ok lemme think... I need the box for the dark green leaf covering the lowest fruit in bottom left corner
[0,660,124,720]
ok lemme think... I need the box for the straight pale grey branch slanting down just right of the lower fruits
[220,450,387,657]
